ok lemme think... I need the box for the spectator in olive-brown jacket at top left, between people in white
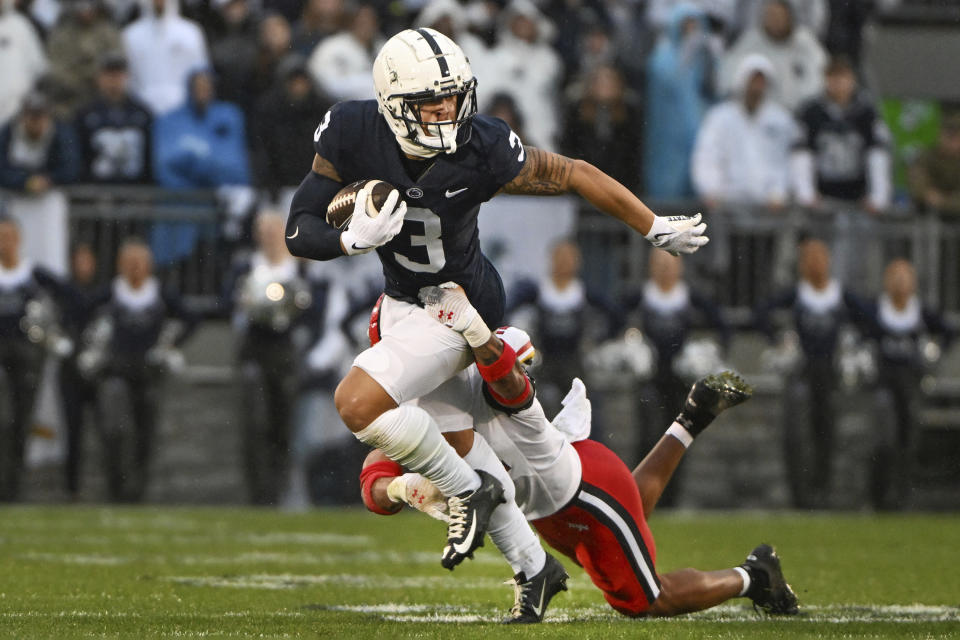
[47,0,123,118]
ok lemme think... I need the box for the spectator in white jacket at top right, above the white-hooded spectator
[719,0,827,111]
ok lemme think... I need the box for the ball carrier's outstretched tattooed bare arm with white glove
[503,147,709,254]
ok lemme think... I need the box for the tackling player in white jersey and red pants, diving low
[361,286,798,622]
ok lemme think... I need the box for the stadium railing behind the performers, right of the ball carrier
[577,201,960,323]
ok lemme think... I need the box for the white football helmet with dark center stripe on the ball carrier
[373,28,477,157]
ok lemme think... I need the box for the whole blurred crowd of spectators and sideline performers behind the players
[0,0,960,506]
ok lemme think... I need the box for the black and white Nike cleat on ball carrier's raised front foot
[440,471,505,571]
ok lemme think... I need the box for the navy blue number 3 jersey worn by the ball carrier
[313,100,525,326]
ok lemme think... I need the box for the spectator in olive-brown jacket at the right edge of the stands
[909,112,960,217]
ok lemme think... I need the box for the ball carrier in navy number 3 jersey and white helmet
[287,29,707,596]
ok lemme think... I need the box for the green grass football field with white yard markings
[0,507,960,640]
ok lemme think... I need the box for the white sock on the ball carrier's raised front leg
[354,405,480,497]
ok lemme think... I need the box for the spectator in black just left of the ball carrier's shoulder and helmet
[252,54,330,204]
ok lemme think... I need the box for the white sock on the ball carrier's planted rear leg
[463,433,547,580]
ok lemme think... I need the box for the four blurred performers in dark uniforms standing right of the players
[508,237,957,510]
